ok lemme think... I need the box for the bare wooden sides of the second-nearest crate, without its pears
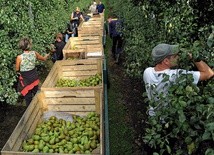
[41,58,103,91]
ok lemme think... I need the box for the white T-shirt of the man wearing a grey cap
[143,67,200,99]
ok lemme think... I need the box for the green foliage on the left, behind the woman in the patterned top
[0,0,91,104]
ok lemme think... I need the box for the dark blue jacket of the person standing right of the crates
[109,18,123,37]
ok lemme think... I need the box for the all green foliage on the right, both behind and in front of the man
[110,0,214,155]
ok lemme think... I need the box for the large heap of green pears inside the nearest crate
[21,112,100,154]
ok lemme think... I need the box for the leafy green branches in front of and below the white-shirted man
[144,76,214,154]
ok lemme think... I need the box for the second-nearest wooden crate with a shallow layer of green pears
[41,58,103,98]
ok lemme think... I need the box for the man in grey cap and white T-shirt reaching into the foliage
[143,44,214,115]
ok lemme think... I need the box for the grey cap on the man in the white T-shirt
[152,44,179,64]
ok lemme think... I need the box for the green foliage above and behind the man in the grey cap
[110,0,214,77]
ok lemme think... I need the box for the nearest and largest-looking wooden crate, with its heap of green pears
[1,92,104,155]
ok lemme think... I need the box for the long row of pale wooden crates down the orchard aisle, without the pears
[1,14,105,155]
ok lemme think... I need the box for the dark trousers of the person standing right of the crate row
[112,36,123,55]
